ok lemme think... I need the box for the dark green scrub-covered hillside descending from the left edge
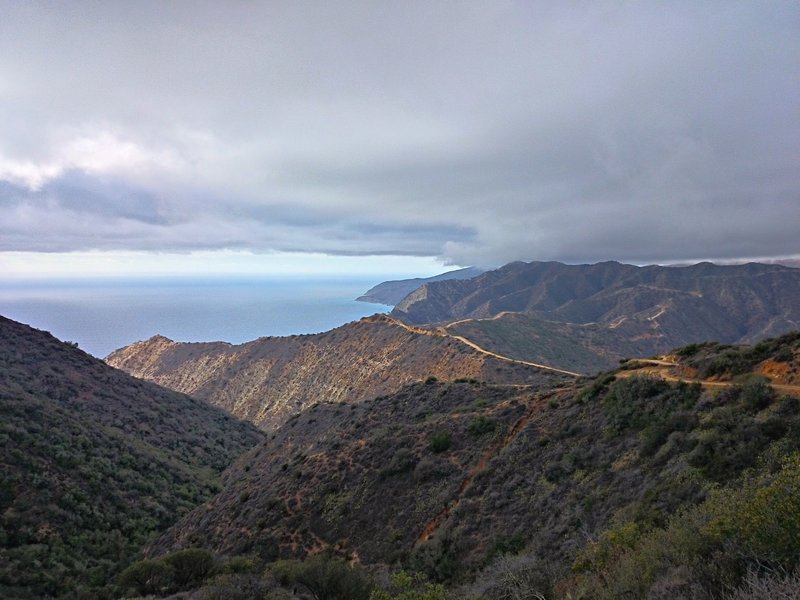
[0,317,261,598]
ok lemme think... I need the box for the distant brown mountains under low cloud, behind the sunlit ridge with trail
[392,262,800,373]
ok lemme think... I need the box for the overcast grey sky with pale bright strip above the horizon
[0,0,800,275]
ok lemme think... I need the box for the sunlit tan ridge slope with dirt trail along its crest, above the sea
[106,315,568,429]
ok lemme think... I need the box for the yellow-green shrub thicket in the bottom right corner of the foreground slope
[573,453,800,600]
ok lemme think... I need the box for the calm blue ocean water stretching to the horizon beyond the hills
[0,278,391,358]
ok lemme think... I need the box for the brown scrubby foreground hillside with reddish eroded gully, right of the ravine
[150,335,800,599]
